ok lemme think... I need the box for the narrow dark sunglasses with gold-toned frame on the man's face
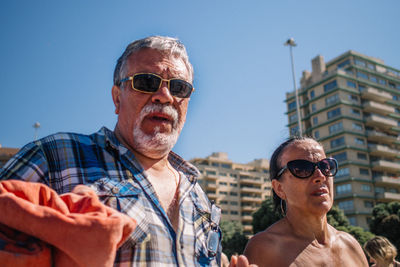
[121,73,194,98]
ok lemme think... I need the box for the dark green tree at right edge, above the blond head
[369,202,400,258]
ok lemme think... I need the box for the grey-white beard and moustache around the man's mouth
[133,103,184,158]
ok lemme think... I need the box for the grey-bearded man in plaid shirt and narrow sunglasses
[0,36,221,266]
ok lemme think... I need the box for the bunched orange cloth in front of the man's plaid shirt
[0,180,136,267]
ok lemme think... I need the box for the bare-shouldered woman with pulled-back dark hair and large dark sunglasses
[231,137,368,267]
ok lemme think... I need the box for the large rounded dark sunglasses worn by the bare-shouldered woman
[277,158,338,179]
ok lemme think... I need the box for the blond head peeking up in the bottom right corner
[364,236,400,267]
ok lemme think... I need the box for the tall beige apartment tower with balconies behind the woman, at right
[286,51,400,228]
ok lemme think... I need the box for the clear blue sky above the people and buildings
[0,0,400,163]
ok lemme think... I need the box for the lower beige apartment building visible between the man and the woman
[191,152,271,236]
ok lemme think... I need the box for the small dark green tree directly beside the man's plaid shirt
[220,221,248,259]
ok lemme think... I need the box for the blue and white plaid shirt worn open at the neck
[0,127,221,266]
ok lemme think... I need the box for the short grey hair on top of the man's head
[114,36,193,86]
